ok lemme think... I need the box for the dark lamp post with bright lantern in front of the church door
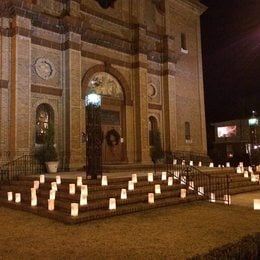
[85,81,102,179]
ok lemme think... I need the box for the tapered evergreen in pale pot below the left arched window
[36,124,59,173]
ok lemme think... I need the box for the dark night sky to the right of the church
[201,0,260,124]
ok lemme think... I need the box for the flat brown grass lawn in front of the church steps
[0,202,260,259]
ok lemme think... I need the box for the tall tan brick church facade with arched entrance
[0,0,207,168]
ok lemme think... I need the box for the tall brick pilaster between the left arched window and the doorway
[63,32,82,169]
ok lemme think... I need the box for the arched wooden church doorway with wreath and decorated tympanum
[88,72,125,164]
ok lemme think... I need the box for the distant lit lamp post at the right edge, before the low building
[248,111,258,164]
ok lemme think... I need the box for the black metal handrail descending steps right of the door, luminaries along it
[158,159,231,204]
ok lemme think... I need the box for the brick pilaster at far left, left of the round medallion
[9,16,31,156]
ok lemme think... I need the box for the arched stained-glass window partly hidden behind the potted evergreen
[35,103,54,144]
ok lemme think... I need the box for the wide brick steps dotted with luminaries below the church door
[0,175,203,224]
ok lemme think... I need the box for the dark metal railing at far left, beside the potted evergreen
[0,155,44,184]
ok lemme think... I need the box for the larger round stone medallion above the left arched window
[34,58,56,80]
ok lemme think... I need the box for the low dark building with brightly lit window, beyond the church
[210,113,260,166]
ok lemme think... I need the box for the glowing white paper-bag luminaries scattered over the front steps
[7,171,230,216]
